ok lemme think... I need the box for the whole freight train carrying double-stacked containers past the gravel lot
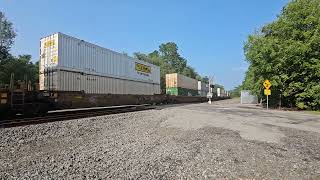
[0,33,228,116]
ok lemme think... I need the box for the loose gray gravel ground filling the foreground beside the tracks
[0,99,320,179]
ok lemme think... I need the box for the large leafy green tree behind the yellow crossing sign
[243,0,320,109]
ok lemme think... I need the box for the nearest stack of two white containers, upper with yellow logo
[39,33,160,95]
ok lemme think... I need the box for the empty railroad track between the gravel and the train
[0,105,155,128]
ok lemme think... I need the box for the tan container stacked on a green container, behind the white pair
[166,73,198,96]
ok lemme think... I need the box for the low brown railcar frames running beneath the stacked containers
[0,89,212,118]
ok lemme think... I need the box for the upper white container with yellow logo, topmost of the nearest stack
[39,33,160,84]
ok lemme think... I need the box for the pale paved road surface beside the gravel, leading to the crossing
[167,99,320,143]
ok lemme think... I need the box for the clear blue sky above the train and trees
[0,0,289,90]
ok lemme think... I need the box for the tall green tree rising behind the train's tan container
[134,42,208,93]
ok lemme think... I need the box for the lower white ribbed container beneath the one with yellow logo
[40,69,160,95]
